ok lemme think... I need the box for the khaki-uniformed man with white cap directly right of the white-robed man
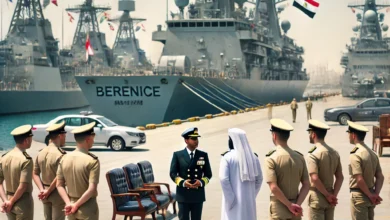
[265,119,310,220]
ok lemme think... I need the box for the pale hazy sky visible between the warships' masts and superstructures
[0,0,390,72]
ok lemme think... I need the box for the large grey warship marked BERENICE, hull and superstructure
[76,0,308,126]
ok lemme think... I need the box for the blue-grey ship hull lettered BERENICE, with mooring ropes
[76,76,308,126]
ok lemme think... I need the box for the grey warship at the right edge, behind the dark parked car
[340,0,390,97]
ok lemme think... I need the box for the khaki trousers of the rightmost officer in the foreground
[351,192,375,220]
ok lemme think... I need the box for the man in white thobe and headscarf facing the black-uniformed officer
[219,128,263,220]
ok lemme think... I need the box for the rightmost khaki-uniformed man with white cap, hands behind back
[347,121,384,220]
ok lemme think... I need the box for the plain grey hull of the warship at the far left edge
[0,90,89,115]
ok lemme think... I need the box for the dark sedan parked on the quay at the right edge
[324,98,390,125]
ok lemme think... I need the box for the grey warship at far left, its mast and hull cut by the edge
[0,0,89,115]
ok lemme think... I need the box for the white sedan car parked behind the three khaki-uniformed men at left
[32,113,146,151]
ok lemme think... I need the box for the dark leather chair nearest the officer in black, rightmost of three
[137,161,177,214]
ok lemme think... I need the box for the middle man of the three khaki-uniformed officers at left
[33,121,66,220]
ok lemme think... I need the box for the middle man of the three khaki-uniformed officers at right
[307,120,344,220]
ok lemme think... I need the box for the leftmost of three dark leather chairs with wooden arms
[106,168,157,220]
